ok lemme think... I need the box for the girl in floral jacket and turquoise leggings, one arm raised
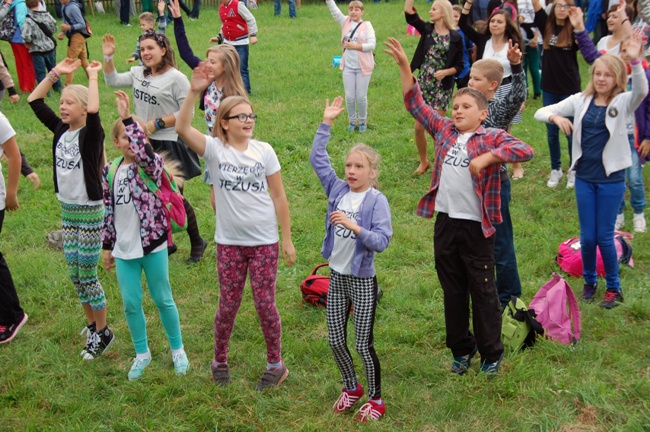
[102,91,190,381]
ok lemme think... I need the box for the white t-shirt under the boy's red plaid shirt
[436,132,482,222]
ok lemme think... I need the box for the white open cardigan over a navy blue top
[535,64,648,177]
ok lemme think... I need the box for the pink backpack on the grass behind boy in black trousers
[528,273,580,345]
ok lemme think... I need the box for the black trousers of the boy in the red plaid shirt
[433,213,503,363]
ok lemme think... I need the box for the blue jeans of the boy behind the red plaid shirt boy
[494,180,521,307]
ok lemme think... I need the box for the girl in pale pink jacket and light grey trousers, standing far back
[326,0,377,132]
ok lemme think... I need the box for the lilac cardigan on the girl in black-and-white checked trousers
[309,123,393,278]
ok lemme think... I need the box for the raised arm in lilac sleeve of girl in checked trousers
[309,96,345,196]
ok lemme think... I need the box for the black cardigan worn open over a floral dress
[404,12,465,90]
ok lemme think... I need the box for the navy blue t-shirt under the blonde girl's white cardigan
[576,99,625,183]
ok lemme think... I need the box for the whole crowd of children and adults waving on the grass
[0,0,650,421]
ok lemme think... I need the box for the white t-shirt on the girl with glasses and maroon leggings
[203,135,280,246]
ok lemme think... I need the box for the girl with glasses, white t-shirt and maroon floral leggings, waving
[176,64,296,390]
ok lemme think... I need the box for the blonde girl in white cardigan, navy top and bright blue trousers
[535,34,648,309]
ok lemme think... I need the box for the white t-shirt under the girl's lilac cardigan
[329,189,370,275]
